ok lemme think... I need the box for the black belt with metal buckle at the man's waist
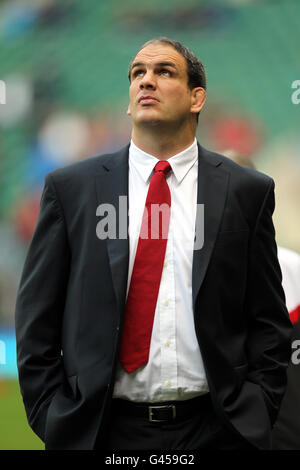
[113,393,211,423]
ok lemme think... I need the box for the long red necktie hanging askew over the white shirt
[120,161,171,373]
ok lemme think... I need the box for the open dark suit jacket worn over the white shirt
[16,145,291,449]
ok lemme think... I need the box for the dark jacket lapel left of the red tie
[96,146,129,312]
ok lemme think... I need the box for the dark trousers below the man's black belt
[105,400,256,451]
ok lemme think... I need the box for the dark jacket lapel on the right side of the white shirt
[192,144,229,308]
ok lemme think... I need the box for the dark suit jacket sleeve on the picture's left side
[15,174,70,440]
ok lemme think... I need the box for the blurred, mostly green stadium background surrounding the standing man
[0,0,300,449]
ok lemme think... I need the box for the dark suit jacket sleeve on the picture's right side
[246,180,292,425]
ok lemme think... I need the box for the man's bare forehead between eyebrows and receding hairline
[131,43,186,70]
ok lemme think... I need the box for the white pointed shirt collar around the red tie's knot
[129,138,198,184]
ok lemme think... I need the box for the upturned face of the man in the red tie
[128,43,198,126]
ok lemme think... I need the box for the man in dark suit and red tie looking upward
[16,38,291,450]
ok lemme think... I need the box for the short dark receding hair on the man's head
[128,37,206,90]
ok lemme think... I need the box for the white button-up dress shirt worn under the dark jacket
[114,139,208,402]
